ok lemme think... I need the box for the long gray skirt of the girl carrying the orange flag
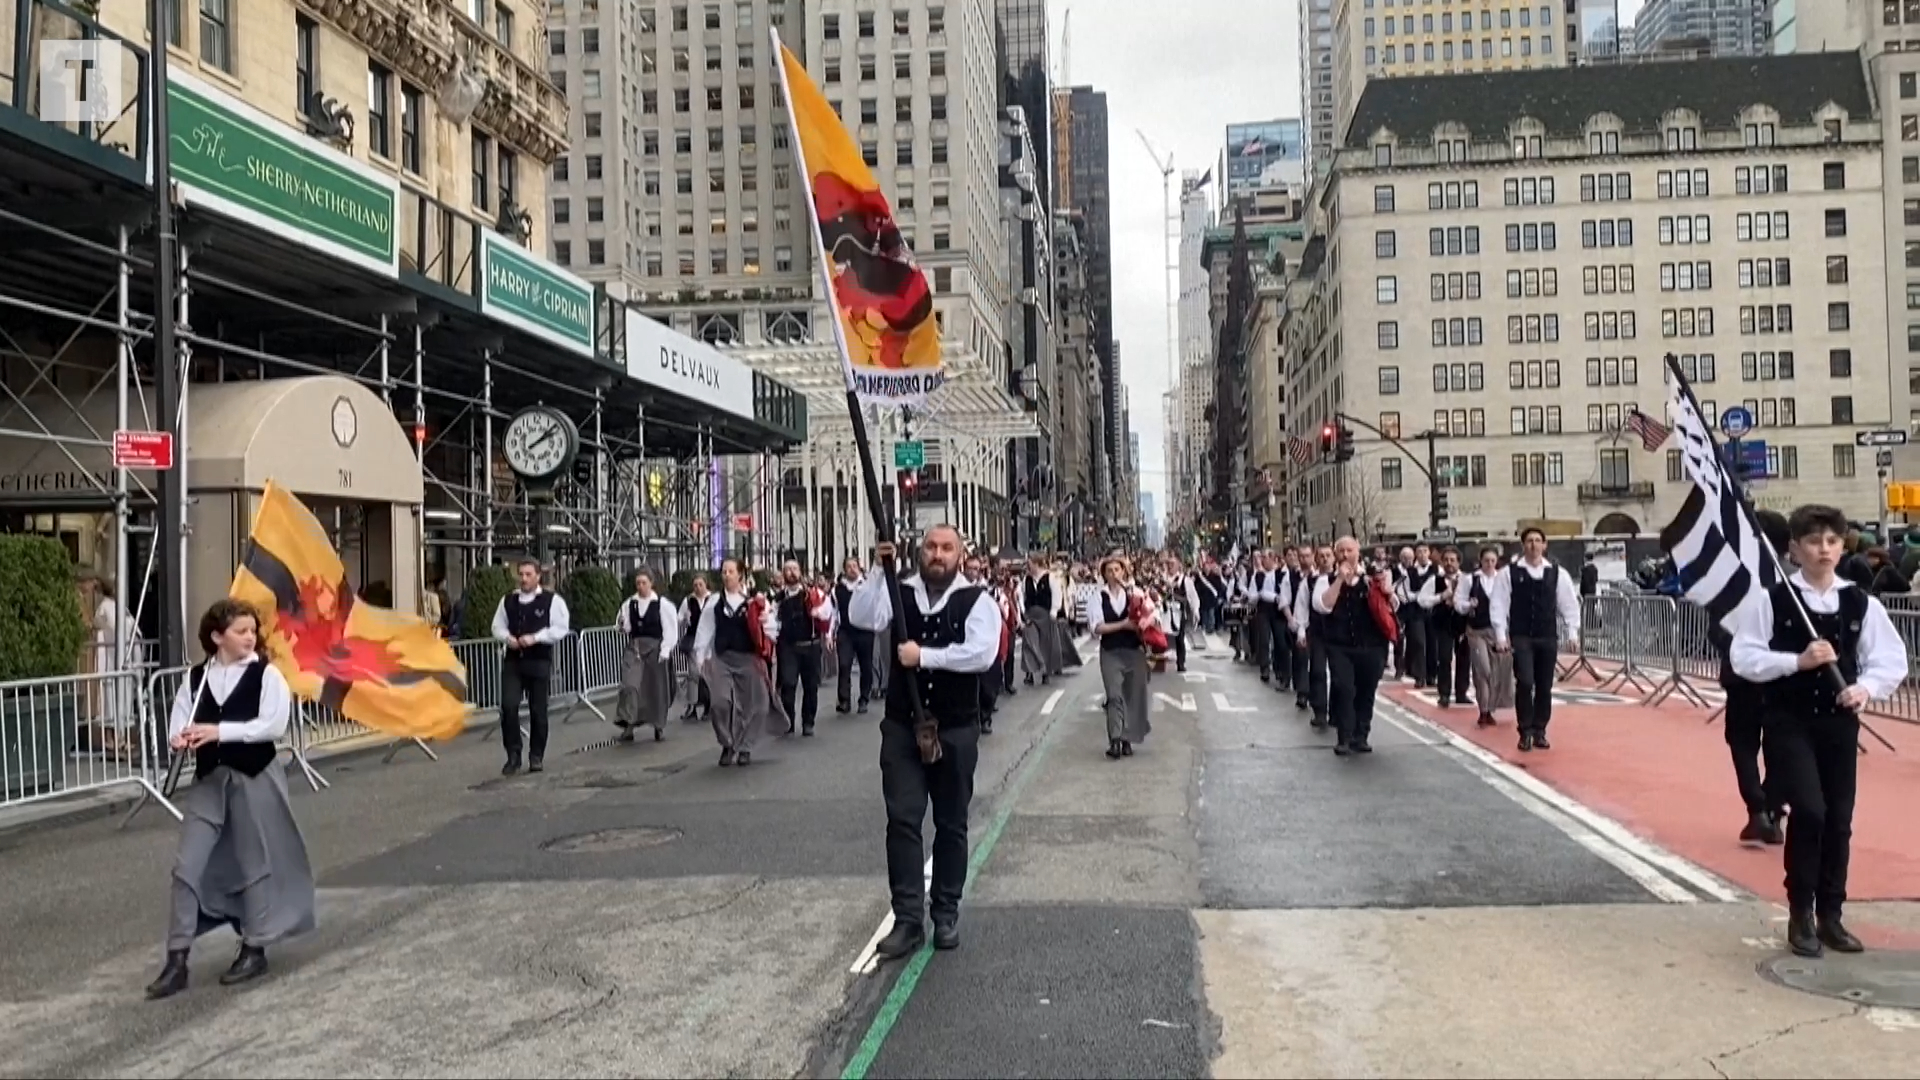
[167,761,315,949]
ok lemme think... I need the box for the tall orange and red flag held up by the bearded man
[774,35,945,405]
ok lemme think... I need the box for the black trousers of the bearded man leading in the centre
[879,719,979,926]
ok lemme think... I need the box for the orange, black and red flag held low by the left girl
[227,480,467,740]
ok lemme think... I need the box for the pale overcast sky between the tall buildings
[1048,0,1642,519]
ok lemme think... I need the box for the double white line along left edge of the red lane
[1382,687,1745,903]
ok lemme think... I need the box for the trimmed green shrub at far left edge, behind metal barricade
[0,536,86,682]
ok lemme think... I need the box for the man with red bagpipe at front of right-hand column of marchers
[1313,536,1398,757]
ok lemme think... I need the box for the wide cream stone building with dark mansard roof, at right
[1290,54,1881,536]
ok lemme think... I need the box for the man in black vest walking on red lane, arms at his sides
[1488,527,1580,751]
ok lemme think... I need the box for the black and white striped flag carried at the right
[1661,354,1780,630]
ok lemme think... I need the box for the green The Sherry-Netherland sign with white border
[167,71,399,277]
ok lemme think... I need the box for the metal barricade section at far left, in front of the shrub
[0,671,180,819]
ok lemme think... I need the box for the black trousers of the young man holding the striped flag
[1766,713,1860,919]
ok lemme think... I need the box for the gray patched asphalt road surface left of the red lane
[0,630,1920,1078]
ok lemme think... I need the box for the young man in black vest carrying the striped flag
[1730,505,1907,957]
